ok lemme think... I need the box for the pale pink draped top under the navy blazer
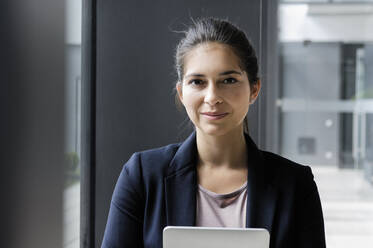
[196,182,247,228]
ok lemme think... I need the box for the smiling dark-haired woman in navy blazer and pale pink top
[102,18,325,248]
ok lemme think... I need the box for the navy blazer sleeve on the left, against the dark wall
[101,153,144,248]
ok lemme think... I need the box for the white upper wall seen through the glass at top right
[279,4,373,42]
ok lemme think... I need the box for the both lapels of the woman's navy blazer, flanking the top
[164,131,277,232]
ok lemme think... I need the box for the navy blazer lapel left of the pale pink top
[164,132,197,226]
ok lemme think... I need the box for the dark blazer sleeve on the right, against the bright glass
[296,166,326,248]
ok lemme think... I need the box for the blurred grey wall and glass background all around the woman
[0,0,373,248]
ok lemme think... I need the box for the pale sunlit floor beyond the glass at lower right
[312,166,373,248]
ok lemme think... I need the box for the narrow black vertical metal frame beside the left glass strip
[80,0,96,248]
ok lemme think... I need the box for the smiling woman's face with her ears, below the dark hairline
[177,42,260,135]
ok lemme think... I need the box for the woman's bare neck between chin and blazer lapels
[196,129,247,169]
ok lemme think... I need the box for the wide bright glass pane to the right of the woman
[277,1,373,248]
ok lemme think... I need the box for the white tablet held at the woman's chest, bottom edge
[163,226,269,248]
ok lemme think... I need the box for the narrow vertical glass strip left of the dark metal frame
[63,0,82,248]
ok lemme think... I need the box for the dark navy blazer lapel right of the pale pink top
[246,136,277,233]
